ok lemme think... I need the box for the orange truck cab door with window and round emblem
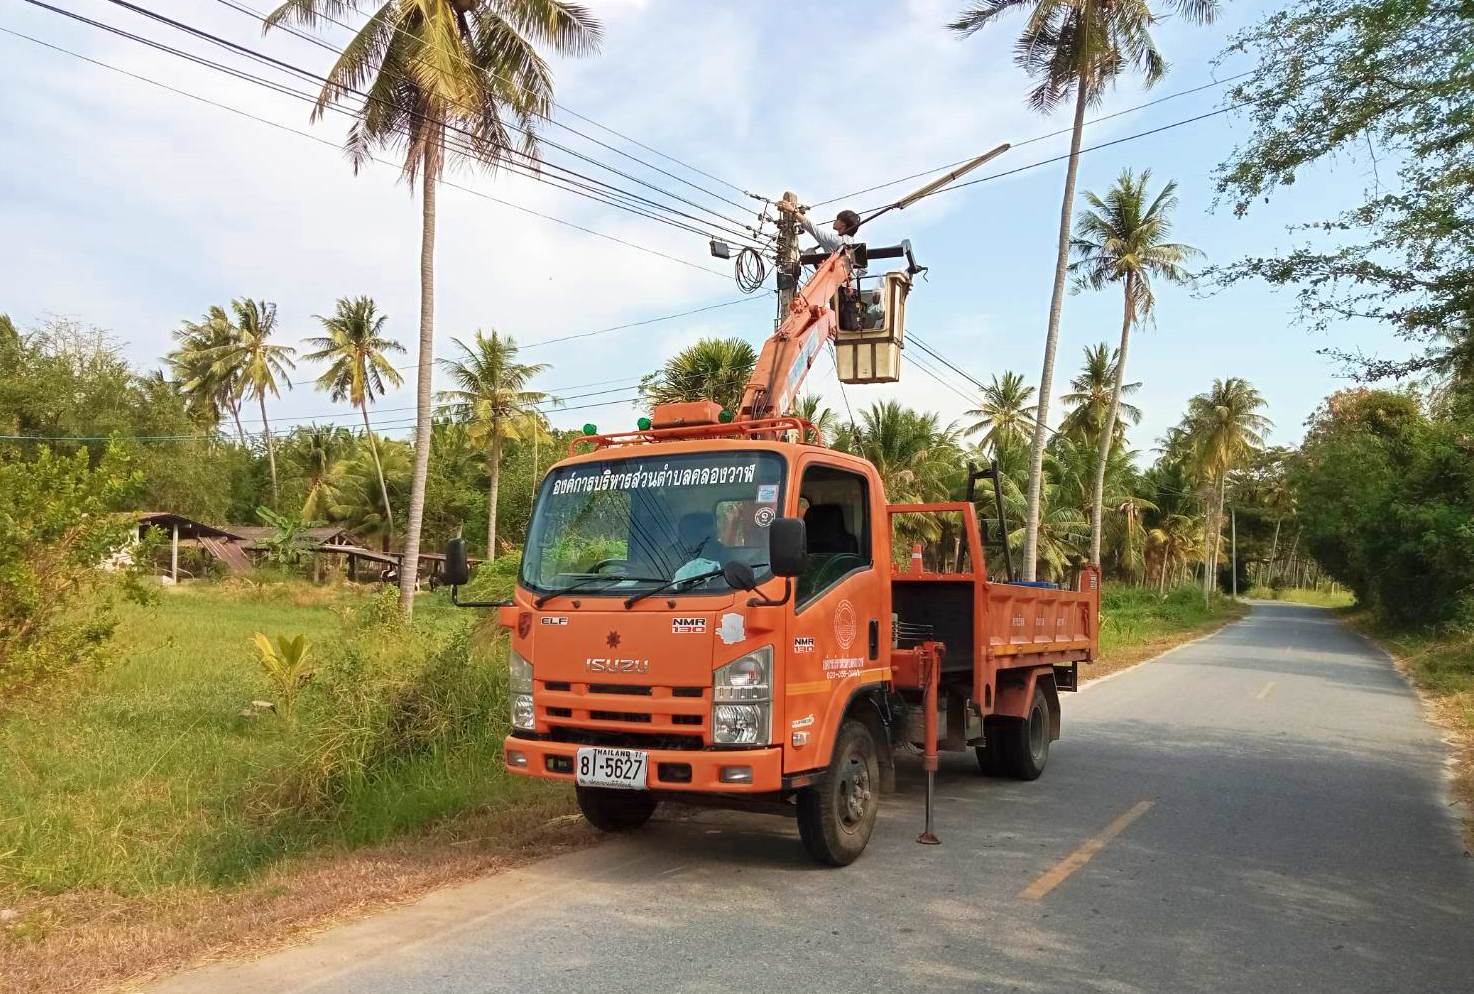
[783,457,890,771]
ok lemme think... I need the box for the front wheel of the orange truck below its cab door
[799,720,880,866]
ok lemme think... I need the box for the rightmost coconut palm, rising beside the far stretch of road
[1184,376,1274,597]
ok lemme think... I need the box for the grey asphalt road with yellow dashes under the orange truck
[143,605,1474,994]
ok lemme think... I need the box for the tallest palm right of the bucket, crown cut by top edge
[948,0,1218,580]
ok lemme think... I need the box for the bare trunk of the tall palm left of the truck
[399,137,441,618]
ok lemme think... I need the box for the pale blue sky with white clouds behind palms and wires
[0,0,1405,459]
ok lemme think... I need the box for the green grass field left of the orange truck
[0,584,566,894]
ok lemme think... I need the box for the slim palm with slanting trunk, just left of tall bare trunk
[302,296,404,544]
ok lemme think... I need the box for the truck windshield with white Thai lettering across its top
[522,451,784,596]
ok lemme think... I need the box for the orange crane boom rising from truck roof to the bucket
[738,246,853,420]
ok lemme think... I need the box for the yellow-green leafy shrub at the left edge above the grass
[0,447,147,699]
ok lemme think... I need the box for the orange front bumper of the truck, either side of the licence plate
[503,736,783,793]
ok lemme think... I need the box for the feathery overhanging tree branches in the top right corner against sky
[1213,0,1474,379]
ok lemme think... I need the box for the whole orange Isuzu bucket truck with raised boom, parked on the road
[445,233,1100,866]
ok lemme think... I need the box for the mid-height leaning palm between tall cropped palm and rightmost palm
[1070,170,1200,562]
